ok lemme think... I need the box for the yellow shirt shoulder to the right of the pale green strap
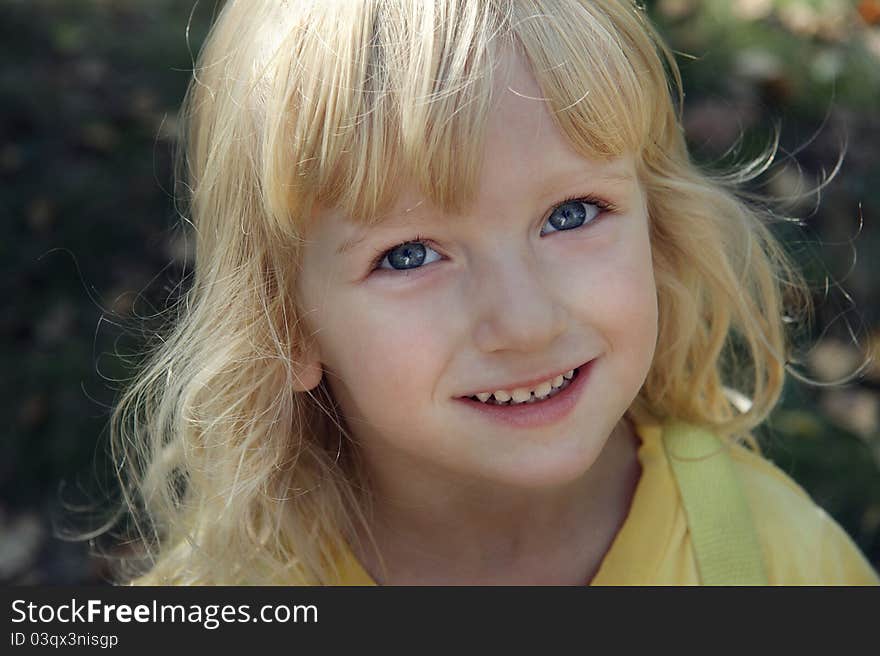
[731,445,880,585]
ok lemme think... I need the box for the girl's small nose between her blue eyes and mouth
[471,247,568,353]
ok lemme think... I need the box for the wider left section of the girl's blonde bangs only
[264,2,502,229]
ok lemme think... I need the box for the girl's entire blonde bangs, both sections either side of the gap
[263,0,671,234]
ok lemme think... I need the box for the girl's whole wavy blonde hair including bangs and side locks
[111,0,811,584]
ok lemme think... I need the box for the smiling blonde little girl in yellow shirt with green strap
[113,0,878,585]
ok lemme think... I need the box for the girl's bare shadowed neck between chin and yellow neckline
[357,419,641,585]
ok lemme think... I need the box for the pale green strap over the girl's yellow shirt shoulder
[663,422,767,585]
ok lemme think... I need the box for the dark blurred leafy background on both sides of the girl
[0,0,880,584]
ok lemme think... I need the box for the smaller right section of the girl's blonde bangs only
[513,0,672,159]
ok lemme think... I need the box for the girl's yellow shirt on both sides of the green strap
[340,426,880,585]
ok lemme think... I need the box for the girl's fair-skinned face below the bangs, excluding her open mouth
[297,52,657,488]
